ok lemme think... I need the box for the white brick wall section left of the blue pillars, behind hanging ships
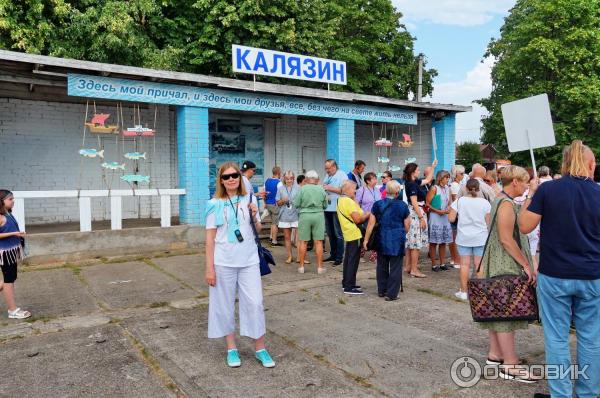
[0,98,178,224]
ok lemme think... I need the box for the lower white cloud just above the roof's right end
[425,57,495,142]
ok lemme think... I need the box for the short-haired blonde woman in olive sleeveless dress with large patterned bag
[478,166,536,383]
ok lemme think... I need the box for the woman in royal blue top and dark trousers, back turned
[363,180,410,301]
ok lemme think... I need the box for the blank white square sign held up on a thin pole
[502,94,556,176]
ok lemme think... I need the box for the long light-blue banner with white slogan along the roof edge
[68,73,417,125]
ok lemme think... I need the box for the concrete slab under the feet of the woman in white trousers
[124,310,378,397]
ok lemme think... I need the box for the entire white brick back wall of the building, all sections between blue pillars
[0,98,432,225]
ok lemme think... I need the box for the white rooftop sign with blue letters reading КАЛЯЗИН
[231,44,346,84]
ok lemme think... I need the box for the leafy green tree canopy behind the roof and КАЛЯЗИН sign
[0,0,437,98]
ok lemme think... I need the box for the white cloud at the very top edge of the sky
[392,0,516,26]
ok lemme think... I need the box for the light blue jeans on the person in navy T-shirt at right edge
[537,274,600,398]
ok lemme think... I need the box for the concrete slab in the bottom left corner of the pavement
[0,325,174,398]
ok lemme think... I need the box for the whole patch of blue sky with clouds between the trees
[392,0,516,142]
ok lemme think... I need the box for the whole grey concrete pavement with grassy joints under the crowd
[0,248,547,397]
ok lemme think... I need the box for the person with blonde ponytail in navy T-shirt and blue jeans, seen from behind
[519,140,600,398]
